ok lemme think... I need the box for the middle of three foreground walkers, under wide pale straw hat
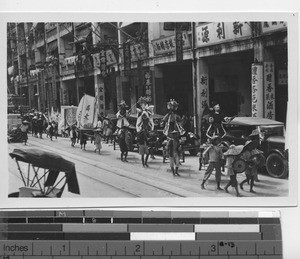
[224,145,244,197]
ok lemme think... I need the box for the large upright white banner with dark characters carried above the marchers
[76,94,98,129]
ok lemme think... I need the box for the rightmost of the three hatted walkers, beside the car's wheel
[240,140,262,193]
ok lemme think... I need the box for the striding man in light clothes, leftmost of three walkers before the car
[201,136,224,190]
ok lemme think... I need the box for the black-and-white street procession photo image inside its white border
[7,22,289,199]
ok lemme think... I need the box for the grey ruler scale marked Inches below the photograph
[0,210,283,259]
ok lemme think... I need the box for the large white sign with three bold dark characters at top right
[196,22,252,47]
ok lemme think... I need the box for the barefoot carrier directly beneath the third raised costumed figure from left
[166,130,180,176]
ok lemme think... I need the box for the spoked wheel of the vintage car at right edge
[266,153,288,178]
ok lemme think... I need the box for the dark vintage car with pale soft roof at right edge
[223,117,288,178]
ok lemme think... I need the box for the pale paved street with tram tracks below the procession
[8,134,288,198]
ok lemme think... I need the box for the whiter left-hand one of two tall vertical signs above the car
[251,63,263,118]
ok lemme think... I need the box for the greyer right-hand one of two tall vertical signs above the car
[264,62,275,120]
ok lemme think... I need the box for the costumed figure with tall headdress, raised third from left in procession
[161,99,185,136]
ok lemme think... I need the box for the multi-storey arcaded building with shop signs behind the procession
[7,21,288,136]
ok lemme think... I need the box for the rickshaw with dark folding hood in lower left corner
[8,149,80,198]
